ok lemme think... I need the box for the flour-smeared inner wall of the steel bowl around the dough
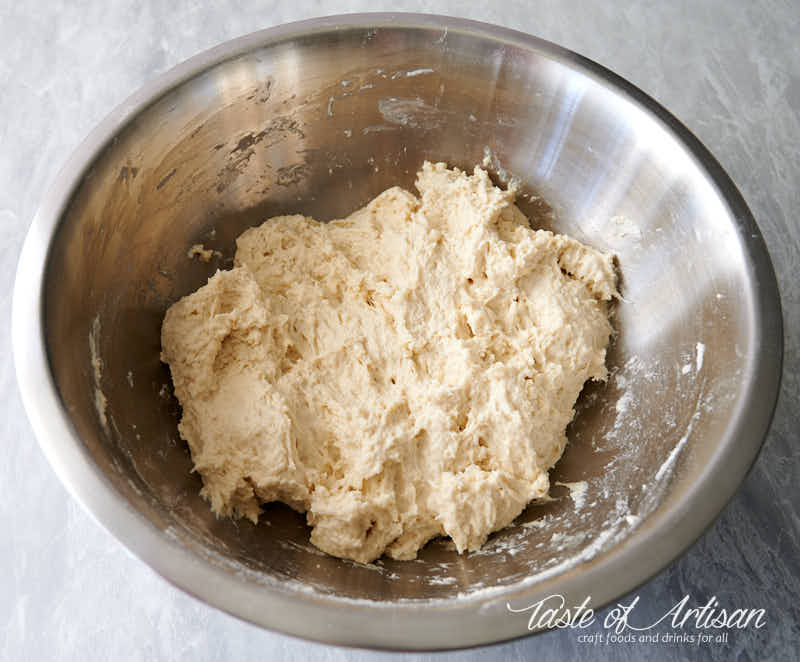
[44,26,754,602]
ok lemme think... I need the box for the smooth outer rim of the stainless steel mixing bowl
[12,13,783,650]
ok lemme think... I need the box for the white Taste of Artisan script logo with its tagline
[506,594,766,644]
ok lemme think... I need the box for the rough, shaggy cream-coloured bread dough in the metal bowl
[162,163,616,562]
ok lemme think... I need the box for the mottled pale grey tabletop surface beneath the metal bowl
[0,0,800,662]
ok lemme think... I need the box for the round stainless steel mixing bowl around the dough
[13,14,782,648]
